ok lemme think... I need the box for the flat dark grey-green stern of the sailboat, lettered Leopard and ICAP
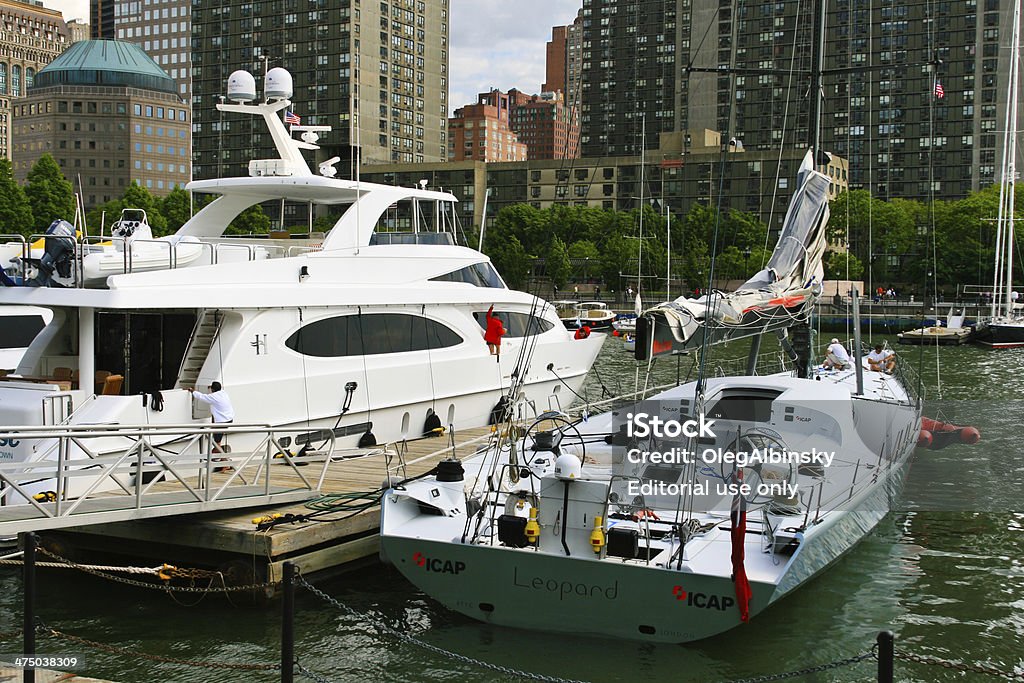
[381,536,774,643]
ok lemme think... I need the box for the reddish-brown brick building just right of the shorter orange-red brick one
[509,90,580,160]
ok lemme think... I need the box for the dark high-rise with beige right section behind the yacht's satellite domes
[191,0,449,184]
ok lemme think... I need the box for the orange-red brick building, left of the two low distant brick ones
[449,90,528,162]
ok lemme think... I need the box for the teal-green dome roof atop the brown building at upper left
[33,40,176,93]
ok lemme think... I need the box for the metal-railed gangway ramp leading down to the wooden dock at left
[0,423,351,537]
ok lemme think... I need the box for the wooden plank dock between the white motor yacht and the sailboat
[40,427,492,585]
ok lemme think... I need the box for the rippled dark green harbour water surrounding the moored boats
[0,333,1024,682]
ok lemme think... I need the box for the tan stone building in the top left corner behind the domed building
[0,0,71,159]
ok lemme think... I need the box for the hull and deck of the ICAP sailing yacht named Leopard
[381,366,920,643]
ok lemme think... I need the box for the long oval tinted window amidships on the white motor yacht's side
[285,313,463,357]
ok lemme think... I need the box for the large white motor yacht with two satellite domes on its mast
[0,69,603,496]
